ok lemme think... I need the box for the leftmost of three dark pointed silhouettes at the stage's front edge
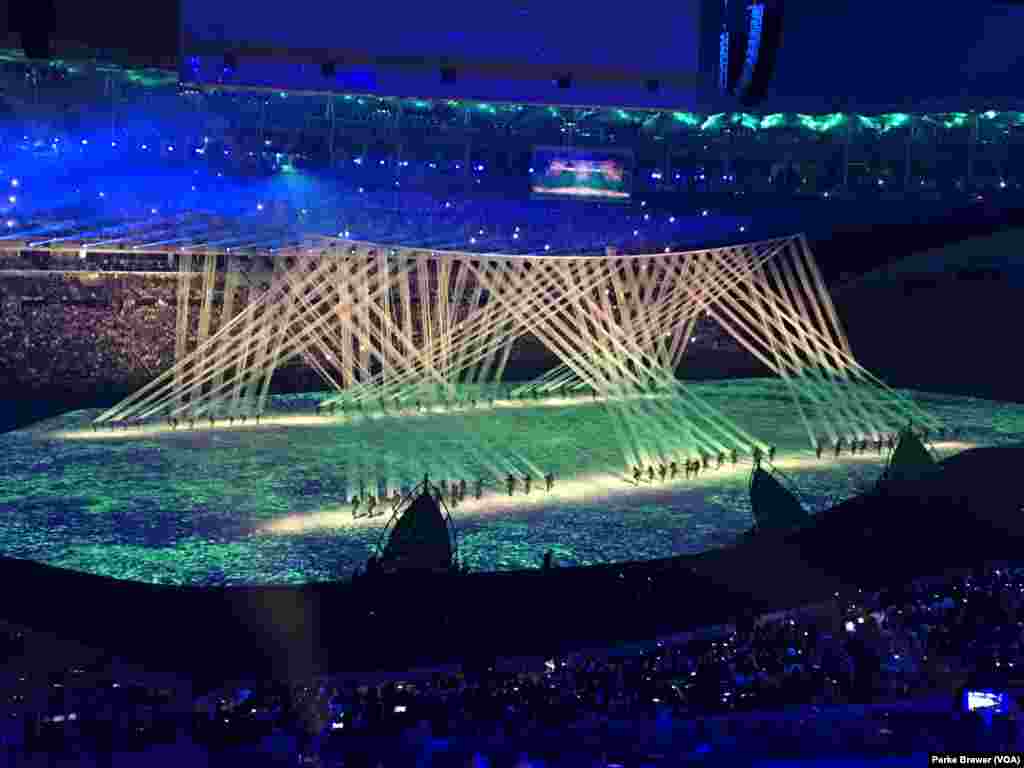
[376,481,457,573]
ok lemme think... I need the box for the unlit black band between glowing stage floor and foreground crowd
[0,445,1024,684]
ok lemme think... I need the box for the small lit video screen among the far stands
[529,146,634,202]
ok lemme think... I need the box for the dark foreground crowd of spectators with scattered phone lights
[4,565,1024,765]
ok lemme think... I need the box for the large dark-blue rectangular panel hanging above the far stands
[180,0,710,109]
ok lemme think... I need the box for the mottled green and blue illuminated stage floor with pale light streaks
[0,380,1024,584]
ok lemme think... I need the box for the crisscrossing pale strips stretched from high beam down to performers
[83,236,937,465]
